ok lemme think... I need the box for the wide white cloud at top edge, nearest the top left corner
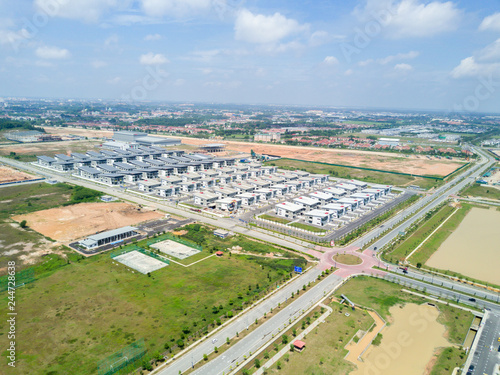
[34,0,122,22]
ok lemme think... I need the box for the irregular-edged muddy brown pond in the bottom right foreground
[351,304,450,375]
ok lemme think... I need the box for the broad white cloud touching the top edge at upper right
[354,0,462,39]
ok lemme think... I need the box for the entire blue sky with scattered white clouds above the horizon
[0,0,500,112]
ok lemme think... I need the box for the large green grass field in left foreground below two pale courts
[0,232,304,374]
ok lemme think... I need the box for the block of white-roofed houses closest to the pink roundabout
[275,180,392,226]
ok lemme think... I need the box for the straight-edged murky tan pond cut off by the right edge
[426,207,500,285]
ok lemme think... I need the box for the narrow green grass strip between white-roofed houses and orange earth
[265,159,442,189]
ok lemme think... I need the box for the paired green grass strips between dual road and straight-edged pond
[385,204,471,265]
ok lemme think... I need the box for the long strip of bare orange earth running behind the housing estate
[178,137,463,176]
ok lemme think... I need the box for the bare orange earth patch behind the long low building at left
[12,203,163,242]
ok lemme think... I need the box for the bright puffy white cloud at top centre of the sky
[234,9,308,44]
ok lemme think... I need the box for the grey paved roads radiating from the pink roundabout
[2,150,500,375]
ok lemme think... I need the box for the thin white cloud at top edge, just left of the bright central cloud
[142,0,211,17]
